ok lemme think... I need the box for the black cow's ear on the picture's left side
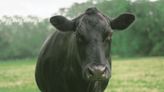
[50,16,75,31]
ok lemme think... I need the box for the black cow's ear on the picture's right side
[111,13,135,30]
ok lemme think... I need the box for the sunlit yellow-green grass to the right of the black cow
[106,57,164,92]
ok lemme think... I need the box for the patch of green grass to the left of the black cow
[0,59,38,92]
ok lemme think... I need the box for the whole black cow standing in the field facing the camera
[35,7,135,92]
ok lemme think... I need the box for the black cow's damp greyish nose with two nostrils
[86,65,109,80]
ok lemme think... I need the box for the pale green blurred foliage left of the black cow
[0,16,51,59]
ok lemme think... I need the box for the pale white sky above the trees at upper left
[0,0,87,18]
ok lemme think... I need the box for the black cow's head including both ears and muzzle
[50,8,135,80]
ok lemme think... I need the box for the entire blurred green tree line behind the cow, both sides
[0,0,164,59]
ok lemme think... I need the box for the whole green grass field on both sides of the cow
[0,57,164,92]
